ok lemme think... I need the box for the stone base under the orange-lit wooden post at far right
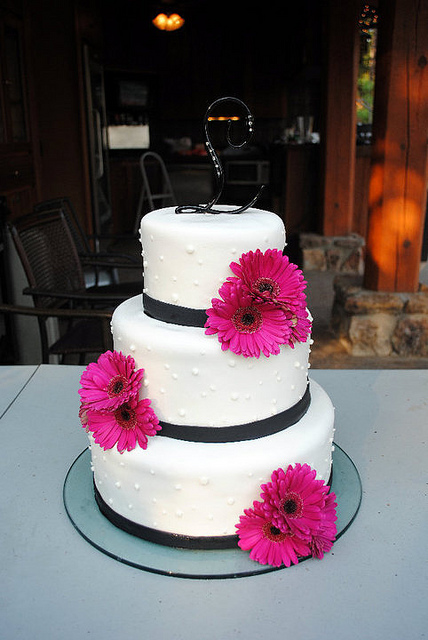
[332,276,428,357]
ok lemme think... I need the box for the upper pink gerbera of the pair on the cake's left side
[79,351,144,411]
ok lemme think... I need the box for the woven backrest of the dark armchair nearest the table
[9,209,85,307]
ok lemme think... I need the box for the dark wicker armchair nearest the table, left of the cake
[4,210,142,362]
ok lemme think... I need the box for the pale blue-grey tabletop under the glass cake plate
[0,365,428,640]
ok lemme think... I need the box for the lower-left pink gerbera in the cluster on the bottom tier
[236,502,310,567]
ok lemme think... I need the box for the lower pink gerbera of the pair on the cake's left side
[82,398,161,453]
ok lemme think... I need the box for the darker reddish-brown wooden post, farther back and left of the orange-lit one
[322,0,361,236]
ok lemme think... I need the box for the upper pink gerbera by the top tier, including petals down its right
[229,249,311,346]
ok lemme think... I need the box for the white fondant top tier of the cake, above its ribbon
[140,205,285,309]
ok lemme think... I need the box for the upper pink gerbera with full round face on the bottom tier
[261,464,328,537]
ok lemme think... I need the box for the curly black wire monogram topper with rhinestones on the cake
[175,97,265,213]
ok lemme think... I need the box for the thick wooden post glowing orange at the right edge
[364,0,428,292]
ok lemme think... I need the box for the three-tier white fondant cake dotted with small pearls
[90,207,334,546]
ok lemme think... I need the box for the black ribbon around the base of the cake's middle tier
[157,384,311,443]
